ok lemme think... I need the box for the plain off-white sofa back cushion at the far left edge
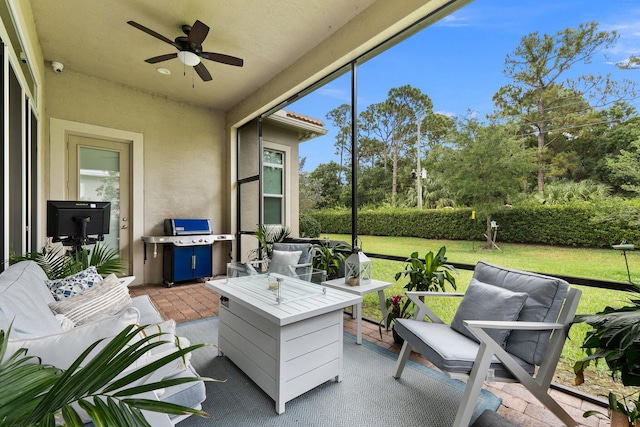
[0,261,62,338]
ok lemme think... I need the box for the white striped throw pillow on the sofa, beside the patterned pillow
[49,274,131,326]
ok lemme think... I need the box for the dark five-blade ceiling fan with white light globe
[127,20,244,82]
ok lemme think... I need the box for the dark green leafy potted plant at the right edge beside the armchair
[574,288,640,426]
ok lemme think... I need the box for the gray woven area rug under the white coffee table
[178,317,501,427]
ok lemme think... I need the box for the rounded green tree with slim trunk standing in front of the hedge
[436,116,535,249]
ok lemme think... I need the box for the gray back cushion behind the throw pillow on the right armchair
[473,262,569,365]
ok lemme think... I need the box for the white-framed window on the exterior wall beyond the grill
[262,148,284,224]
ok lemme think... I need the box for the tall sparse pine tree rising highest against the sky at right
[493,22,635,191]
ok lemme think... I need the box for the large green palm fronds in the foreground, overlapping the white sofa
[0,325,210,427]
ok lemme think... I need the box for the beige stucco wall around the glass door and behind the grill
[43,70,231,283]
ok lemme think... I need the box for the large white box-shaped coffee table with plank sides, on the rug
[207,274,362,414]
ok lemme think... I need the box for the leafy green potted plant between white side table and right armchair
[395,246,457,292]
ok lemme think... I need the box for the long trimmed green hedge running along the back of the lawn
[309,202,640,248]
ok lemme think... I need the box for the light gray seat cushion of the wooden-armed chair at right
[394,319,534,378]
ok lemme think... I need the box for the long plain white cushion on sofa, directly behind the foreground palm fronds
[5,307,140,369]
